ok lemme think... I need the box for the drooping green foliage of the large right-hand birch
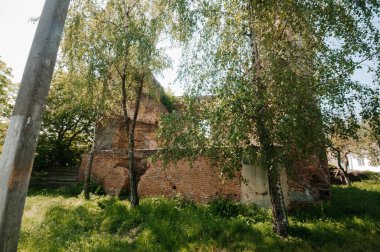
[160,0,380,176]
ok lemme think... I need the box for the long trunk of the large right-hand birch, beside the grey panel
[248,2,289,237]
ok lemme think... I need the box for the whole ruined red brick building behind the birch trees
[80,90,330,208]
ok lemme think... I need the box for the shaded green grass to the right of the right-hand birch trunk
[290,182,380,251]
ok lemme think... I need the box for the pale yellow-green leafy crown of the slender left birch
[62,0,170,112]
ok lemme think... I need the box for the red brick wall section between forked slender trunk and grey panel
[138,157,241,203]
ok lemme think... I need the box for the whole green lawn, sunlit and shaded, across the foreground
[19,180,380,251]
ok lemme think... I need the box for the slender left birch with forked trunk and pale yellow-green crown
[66,0,168,206]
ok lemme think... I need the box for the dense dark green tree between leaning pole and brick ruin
[34,72,95,169]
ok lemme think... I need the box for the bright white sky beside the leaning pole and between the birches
[0,0,183,95]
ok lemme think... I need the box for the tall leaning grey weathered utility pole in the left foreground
[0,0,70,252]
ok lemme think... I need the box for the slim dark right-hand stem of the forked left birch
[128,75,144,207]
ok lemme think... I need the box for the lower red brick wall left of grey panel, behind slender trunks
[80,155,241,203]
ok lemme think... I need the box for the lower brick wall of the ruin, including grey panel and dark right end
[80,149,330,208]
